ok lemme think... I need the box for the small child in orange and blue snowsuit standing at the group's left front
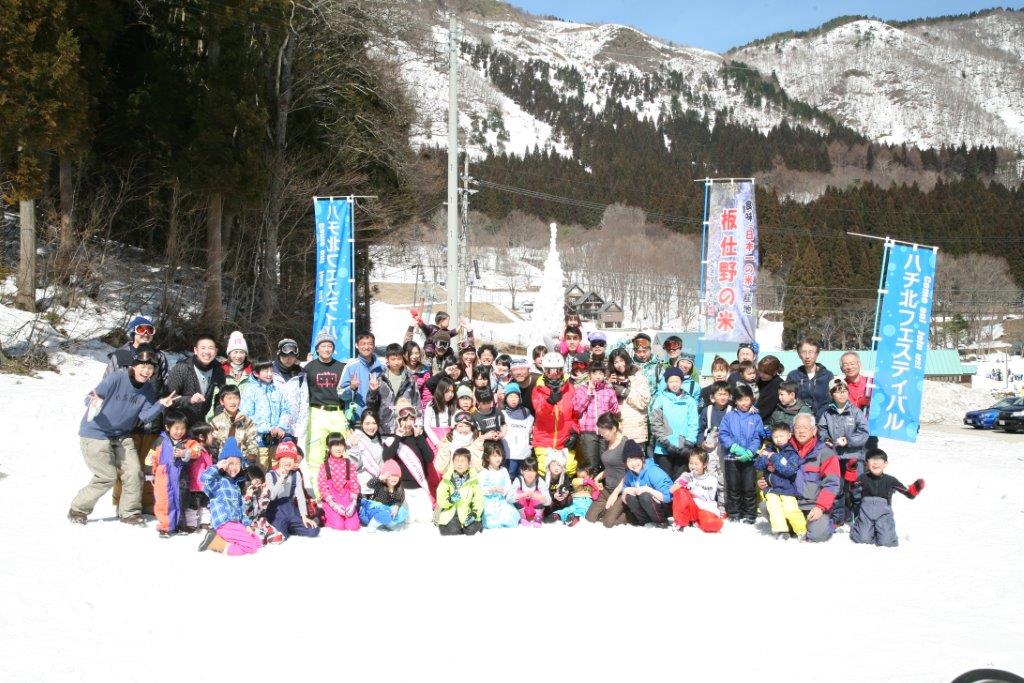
[145,413,199,539]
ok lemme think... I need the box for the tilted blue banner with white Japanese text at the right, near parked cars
[867,245,937,443]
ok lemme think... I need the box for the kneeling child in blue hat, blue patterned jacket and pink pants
[199,436,263,555]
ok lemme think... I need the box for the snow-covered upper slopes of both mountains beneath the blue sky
[387,0,1024,158]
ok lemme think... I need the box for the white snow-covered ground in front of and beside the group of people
[0,346,1024,683]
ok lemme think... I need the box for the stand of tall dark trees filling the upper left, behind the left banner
[0,0,433,352]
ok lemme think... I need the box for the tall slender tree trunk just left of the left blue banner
[262,24,296,316]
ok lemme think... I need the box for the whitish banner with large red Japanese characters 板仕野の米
[703,180,760,342]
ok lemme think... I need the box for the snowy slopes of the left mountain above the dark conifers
[398,2,839,157]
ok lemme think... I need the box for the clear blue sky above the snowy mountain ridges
[511,0,1024,52]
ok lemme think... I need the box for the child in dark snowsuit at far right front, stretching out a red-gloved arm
[850,449,925,548]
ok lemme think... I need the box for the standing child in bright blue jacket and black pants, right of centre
[719,384,768,524]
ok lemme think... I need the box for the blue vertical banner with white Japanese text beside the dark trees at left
[309,197,355,359]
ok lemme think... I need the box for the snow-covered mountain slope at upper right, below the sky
[730,11,1024,150]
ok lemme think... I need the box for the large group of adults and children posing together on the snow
[68,310,924,554]
